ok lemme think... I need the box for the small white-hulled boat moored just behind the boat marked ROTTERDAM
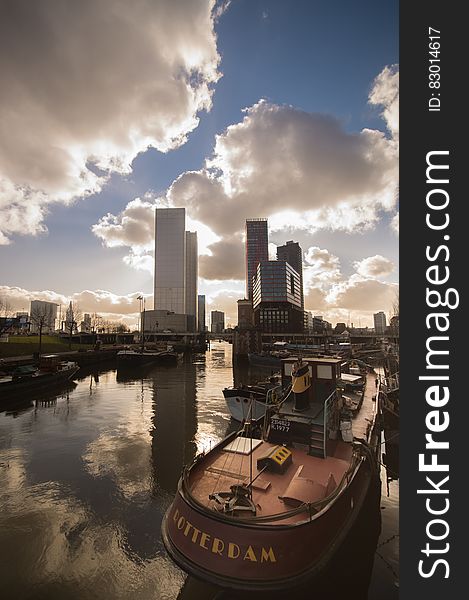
[223,376,283,422]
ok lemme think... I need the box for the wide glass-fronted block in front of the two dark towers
[252,260,304,333]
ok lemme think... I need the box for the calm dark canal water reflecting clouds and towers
[0,342,399,600]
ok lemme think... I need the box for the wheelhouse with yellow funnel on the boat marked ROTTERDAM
[266,357,342,458]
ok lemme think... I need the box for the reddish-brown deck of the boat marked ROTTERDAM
[188,374,376,525]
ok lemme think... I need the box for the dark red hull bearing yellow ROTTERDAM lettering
[162,446,379,590]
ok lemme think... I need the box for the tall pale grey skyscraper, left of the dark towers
[154,208,198,331]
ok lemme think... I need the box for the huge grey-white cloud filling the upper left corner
[0,0,219,243]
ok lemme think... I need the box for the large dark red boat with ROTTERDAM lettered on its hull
[162,358,380,591]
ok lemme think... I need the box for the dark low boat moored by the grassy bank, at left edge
[0,354,80,400]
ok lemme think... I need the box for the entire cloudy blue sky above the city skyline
[0,0,399,327]
